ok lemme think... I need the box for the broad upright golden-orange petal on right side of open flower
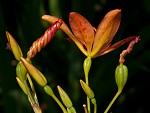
[91,9,121,57]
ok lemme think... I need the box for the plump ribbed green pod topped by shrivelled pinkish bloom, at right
[115,64,128,91]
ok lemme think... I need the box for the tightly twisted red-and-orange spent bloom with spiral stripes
[27,19,62,58]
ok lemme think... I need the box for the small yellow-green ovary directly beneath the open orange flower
[83,57,92,76]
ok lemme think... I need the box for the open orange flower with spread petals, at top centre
[42,9,135,58]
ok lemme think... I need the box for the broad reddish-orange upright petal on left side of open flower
[69,12,94,52]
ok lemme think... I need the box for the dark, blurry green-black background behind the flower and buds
[0,0,150,113]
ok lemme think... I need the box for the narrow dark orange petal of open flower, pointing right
[95,36,137,57]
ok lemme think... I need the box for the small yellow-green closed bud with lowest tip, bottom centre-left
[57,86,73,108]
